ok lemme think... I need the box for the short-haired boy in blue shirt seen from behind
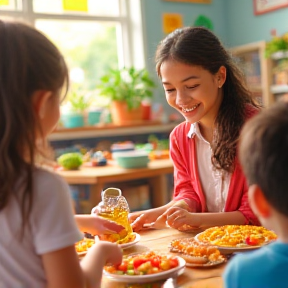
[224,102,288,288]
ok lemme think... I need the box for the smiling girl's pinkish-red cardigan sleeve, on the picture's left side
[170,129,201,212]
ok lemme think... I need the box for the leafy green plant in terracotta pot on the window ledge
[97,67,156,125]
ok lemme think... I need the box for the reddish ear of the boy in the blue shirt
[248,184,271,218]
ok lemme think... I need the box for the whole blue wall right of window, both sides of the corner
[141,0,288,114]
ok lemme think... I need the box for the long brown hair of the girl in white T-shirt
[0,20,68,230]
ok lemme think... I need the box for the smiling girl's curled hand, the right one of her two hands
[157,206,199,230]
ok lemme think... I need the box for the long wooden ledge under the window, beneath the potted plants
[48,121,179,141]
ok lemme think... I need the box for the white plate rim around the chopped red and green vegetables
[103,256,186,283]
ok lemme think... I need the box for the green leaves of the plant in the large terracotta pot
[97,67,156,110]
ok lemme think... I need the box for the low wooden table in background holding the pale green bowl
[57,159,173,210]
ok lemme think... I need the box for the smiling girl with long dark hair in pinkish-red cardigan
[129,27,259,231]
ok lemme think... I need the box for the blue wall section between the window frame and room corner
[141,0,227,114]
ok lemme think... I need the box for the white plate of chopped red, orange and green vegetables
[103,251,185,283]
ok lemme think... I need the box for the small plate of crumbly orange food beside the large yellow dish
[170,237,226,267]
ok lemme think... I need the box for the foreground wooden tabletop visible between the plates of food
[101,228,226,288]
